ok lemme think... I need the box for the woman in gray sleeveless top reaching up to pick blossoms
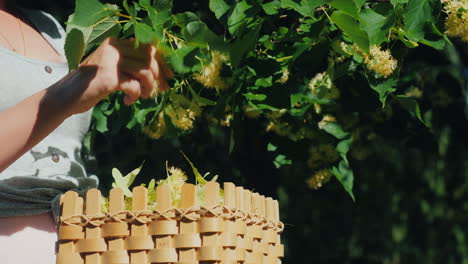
[0,0,171,264]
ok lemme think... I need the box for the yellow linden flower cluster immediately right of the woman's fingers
[194,50,229,91]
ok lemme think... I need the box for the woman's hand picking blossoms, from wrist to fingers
[60,38,172,114]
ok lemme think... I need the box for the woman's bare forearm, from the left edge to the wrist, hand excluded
[0,69,85,172]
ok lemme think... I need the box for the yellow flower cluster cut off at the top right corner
[444,0,468,42]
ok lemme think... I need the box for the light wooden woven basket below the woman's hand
[57,182,284,264]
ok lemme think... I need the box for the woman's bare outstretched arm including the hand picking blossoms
[0,37,172,172]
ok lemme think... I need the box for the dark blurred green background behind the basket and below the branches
[24,0,468,264]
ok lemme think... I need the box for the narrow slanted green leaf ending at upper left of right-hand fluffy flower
[331,11,369,52]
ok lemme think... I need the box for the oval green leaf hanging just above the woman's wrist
[64,28,86,70]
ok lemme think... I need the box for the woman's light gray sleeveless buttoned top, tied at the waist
[0,9,97,219]
